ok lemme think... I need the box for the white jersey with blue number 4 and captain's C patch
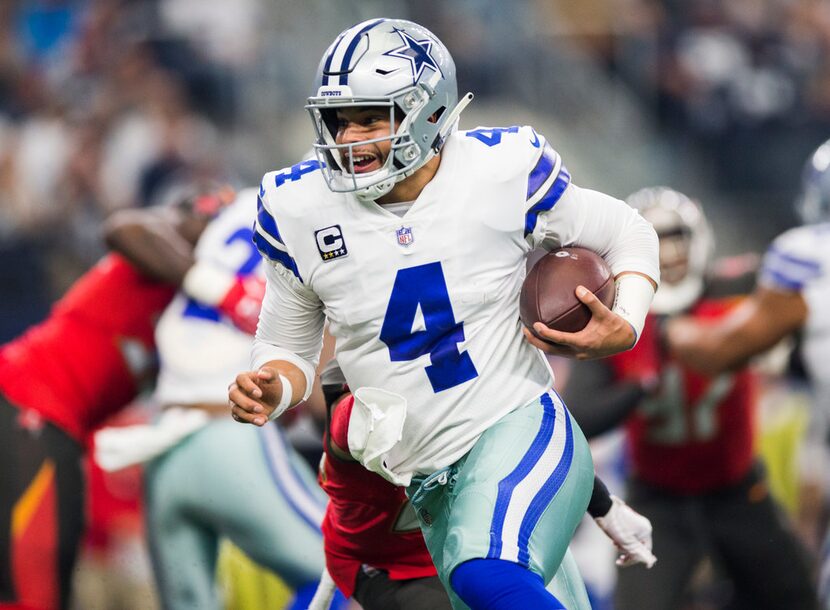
[253,127,659,474]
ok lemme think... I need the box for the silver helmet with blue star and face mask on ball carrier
[306,19,472,200]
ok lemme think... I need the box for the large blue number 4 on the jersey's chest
[380,263,478,392]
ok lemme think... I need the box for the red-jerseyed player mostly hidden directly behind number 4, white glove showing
[314,360,655,610]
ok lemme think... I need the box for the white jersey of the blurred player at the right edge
[759,223,830,402]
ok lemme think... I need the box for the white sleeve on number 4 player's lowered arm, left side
[251,259,325,400]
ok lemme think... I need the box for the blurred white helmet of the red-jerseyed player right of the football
[626,187,715,315]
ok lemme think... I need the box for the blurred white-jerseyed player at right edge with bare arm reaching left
[666,142,830,607]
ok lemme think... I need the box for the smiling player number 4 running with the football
[229,19,659,609]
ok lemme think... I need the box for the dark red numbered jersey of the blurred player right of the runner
[610,301,755,494]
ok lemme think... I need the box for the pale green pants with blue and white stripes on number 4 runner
[407,392,594,609]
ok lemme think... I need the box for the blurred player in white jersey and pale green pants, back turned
[96,189,342,610]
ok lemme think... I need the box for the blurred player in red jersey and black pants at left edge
[0,186,231,609]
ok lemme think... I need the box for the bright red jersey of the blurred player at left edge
[0,254,176,442]
